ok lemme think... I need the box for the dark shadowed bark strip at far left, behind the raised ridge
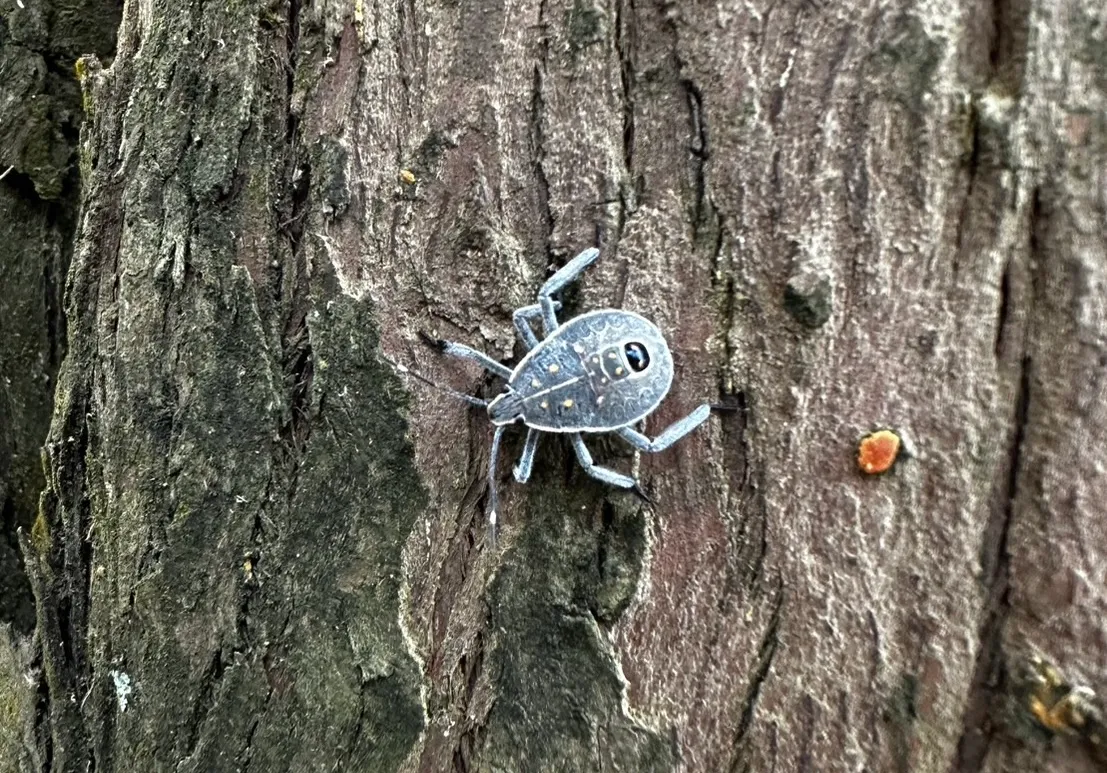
[0,0,122,633]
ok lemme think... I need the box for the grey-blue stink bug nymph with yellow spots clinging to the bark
[414,248,712,536]
